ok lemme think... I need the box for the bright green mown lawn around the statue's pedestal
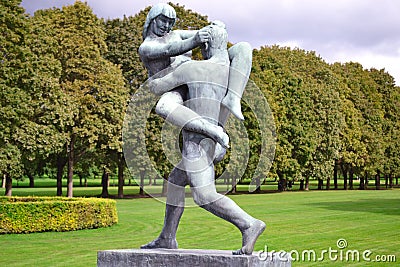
[0,189,400,267]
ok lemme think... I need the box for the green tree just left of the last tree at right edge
[332,62,385,189]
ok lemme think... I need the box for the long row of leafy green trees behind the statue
[0,0,400,197]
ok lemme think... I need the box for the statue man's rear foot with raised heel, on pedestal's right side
[232,220,265,255]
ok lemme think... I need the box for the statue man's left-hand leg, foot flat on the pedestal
[140,168,187,249]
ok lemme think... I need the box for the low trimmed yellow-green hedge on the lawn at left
[0,197,118,234]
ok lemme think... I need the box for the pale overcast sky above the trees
[22,0,400,85]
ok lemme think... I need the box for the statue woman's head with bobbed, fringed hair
[142,3,176,40]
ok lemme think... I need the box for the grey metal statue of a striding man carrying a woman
[139,4,265,255]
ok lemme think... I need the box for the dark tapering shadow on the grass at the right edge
[307,198,400,218]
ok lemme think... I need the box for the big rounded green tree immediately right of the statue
[252,46,343,189]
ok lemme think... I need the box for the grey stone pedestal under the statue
[97,249,291,267]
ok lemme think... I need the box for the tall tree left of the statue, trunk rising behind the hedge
[28,1,127,197]
